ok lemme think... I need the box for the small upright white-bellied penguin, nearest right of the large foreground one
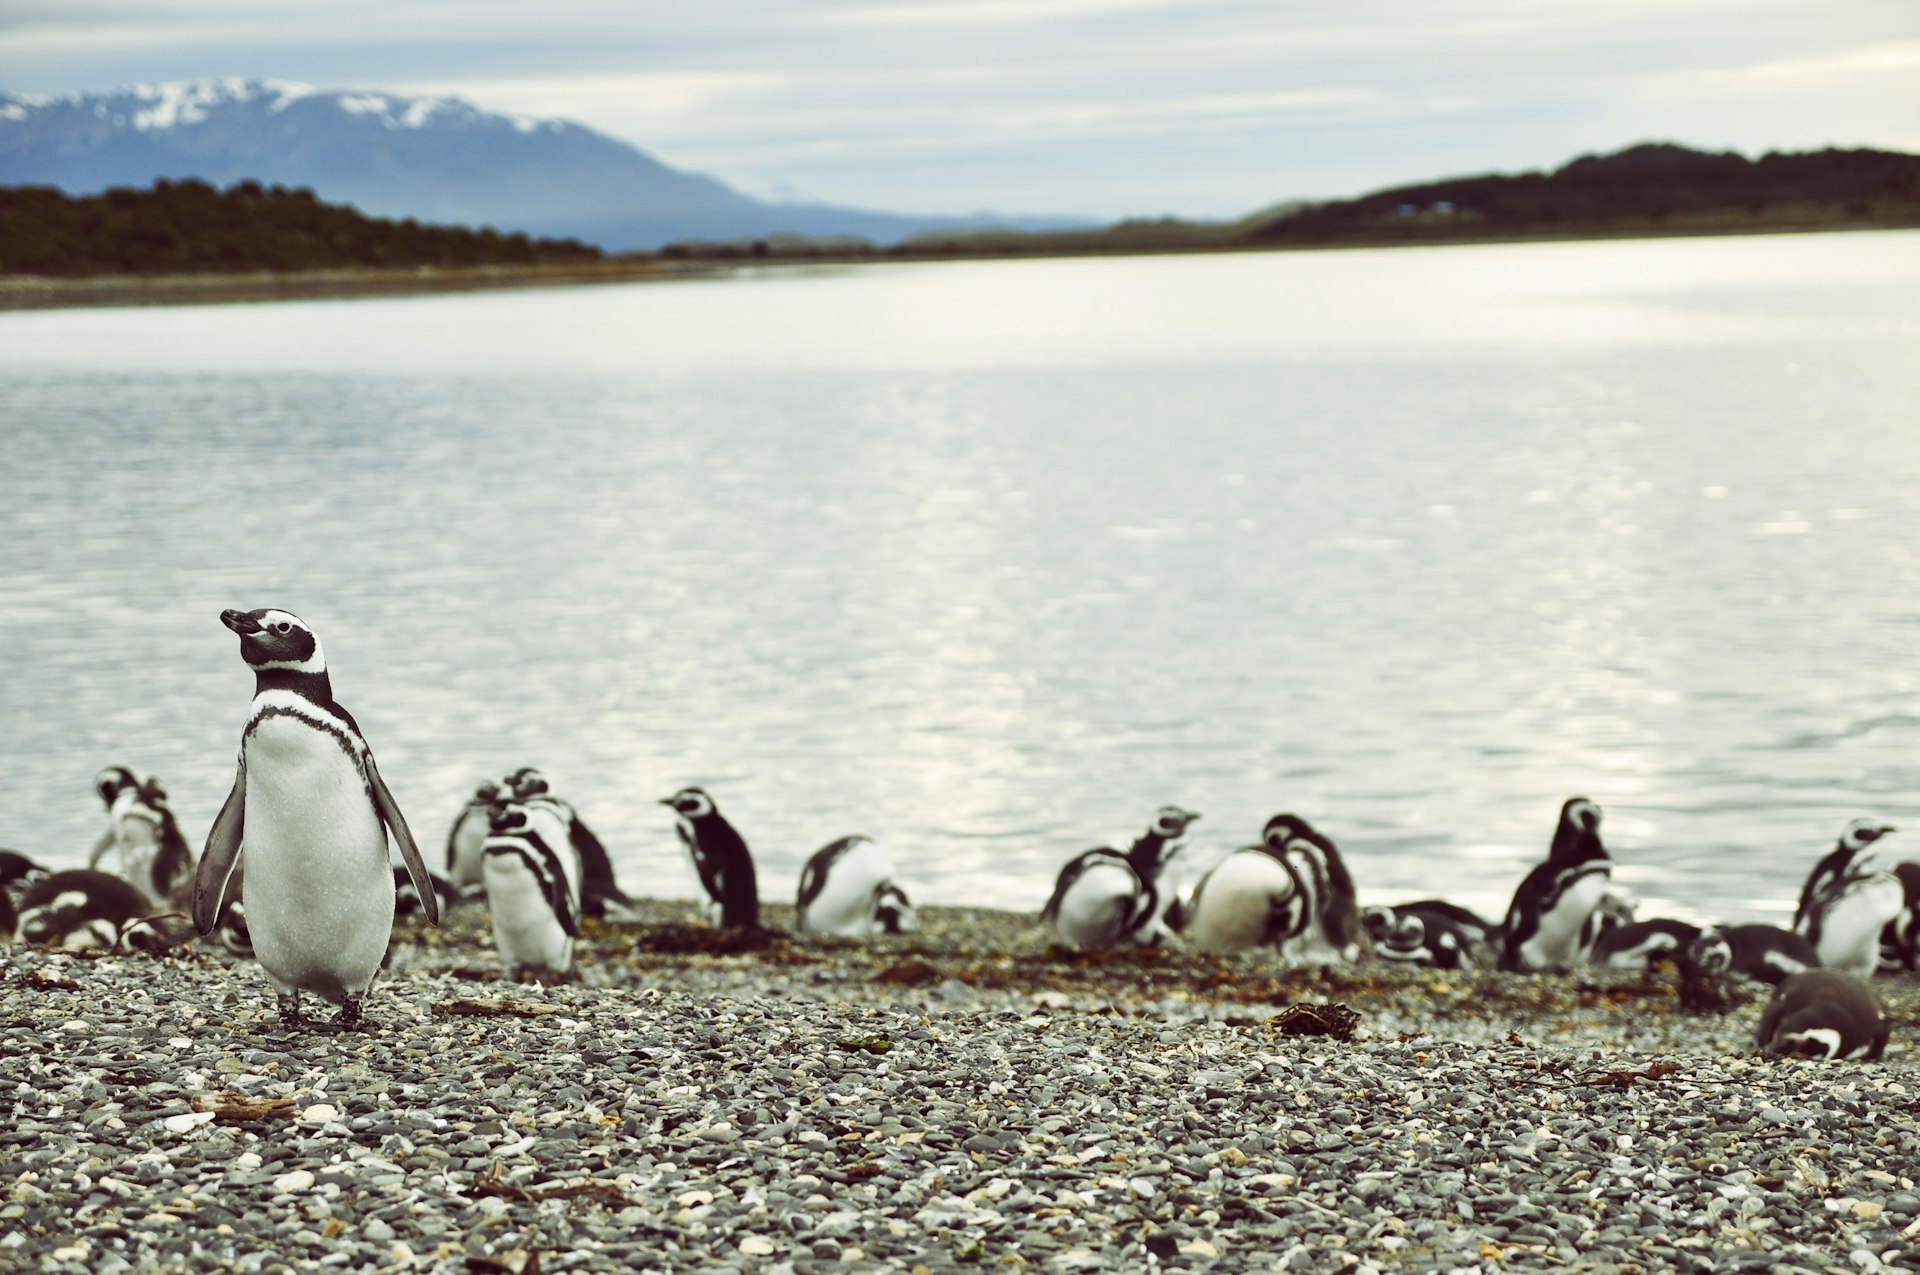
[484,799,580,981]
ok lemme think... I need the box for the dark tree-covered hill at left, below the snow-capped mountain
[0,180,601,277]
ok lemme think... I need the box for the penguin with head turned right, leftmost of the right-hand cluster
[1041,806,1200,947]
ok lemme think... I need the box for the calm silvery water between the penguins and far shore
[0,232,1920,920]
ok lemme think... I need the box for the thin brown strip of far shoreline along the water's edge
[0,225,1920,313]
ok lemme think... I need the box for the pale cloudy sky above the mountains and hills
[0,0,1920,219]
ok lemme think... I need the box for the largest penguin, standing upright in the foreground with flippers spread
[194,607,440,1031]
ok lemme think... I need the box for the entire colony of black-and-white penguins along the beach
[0,607,1920,1058]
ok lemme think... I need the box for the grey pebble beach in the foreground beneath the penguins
[0,902,1920,1275]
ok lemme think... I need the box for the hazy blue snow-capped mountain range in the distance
[0,79,1085,252]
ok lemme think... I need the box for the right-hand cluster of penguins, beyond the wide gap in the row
[1041,797,1920,1058]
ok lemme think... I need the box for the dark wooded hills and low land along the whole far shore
[0,142,1920,291]
